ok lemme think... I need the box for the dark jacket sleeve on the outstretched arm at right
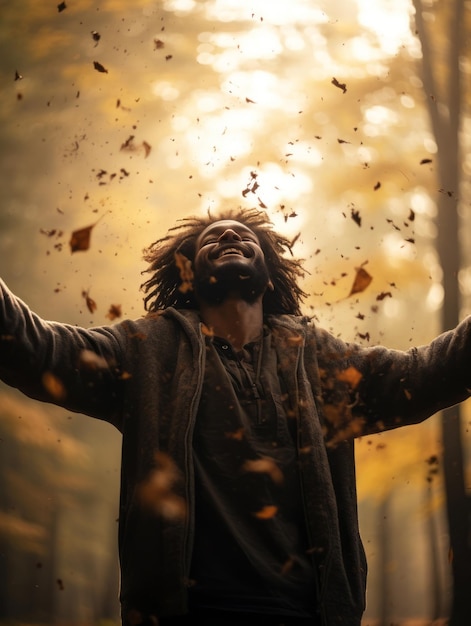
[315,317,471,440]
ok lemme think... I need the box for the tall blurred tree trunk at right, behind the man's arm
[413,0,471,626]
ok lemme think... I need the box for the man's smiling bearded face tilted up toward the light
[194,220,270,304]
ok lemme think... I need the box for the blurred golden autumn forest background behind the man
[0,0,471,626]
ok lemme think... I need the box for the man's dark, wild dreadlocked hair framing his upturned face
[141,208,307,315]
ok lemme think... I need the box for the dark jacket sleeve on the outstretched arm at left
[0,280,126,425]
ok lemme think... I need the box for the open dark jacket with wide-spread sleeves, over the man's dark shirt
[0,281,471,626]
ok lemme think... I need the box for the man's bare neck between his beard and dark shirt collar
[200,297,263,350]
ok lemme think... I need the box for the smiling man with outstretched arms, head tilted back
[0,209,471,626]
